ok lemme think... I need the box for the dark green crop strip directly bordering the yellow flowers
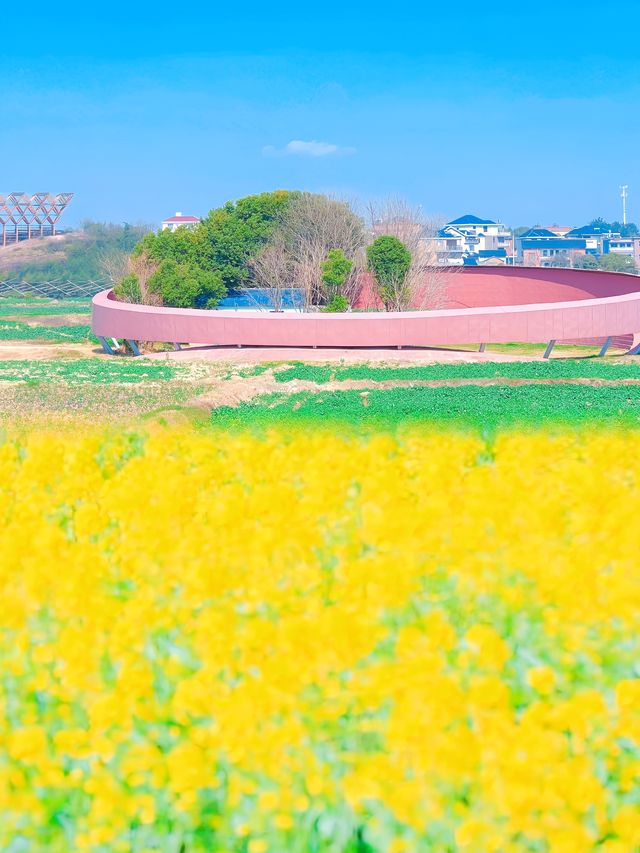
[212,385,640,432]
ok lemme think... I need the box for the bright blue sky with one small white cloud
[0,0,640,225]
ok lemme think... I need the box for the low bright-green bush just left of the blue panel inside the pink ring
[148,258,227,308]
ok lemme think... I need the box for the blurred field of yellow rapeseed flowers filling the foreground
[0,427,640,853]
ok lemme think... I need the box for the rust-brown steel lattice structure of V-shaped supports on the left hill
[0,193,73,246]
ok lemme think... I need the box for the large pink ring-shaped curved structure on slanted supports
[92,267,640,348]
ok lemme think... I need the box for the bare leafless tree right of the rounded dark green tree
[367,196,458,311]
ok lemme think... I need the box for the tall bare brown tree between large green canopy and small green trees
[280,193,365,310]
